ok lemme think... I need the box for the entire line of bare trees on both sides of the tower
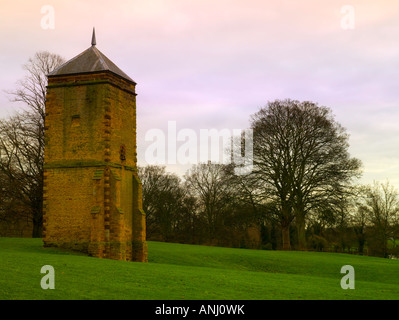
[0,52,399,257]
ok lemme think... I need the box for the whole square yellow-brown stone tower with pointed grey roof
[43,29,147,261]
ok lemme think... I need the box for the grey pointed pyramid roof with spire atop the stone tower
[48,28,136,84]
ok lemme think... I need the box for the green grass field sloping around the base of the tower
[0,238,399,300]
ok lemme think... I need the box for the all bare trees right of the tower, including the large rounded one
[139,88,399,257]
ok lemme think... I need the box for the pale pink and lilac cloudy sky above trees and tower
[0,0,399,187]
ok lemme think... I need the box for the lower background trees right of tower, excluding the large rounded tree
[139,163,399,257]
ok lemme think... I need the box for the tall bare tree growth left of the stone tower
[0,51,64,237]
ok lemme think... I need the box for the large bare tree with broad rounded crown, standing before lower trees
[252,99,360,249]
